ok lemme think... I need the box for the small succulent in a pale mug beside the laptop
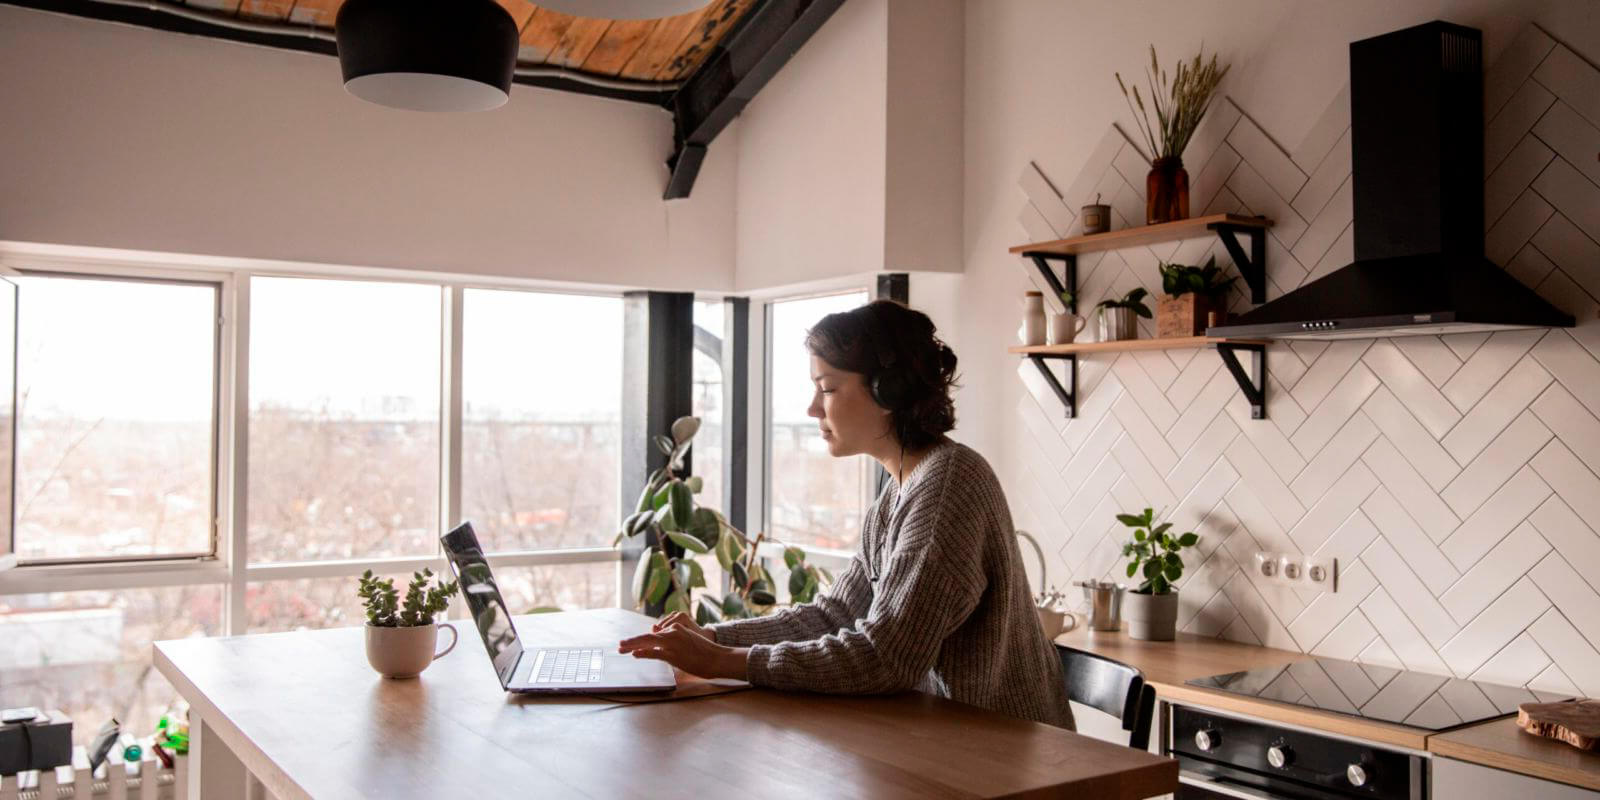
[355,570,456,678]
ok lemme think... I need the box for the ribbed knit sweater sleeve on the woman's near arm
[746,474,986,694]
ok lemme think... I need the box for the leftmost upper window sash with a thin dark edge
[6,274,221,563]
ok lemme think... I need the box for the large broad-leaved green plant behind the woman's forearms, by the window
[611,416,834,626]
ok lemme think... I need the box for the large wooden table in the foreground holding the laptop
[155,610,1178,800]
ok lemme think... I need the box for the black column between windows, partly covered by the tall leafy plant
[618,291,694,611]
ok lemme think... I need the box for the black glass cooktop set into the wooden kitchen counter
[1187,658,1568,731]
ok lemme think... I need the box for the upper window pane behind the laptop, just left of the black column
[461,290,622,552]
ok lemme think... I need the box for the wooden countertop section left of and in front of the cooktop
[1056,627,1427,750]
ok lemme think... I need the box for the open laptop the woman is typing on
[440,522,678,694]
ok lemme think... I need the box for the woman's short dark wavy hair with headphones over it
[805,299,955,450]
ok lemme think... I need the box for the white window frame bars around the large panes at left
[0,242,624,635]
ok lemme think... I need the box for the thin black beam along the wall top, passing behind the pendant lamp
[0,0,674,107]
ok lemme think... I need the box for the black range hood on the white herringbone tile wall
[1206,22,1574,339]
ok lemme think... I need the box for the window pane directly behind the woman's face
[766,291,875,550]
